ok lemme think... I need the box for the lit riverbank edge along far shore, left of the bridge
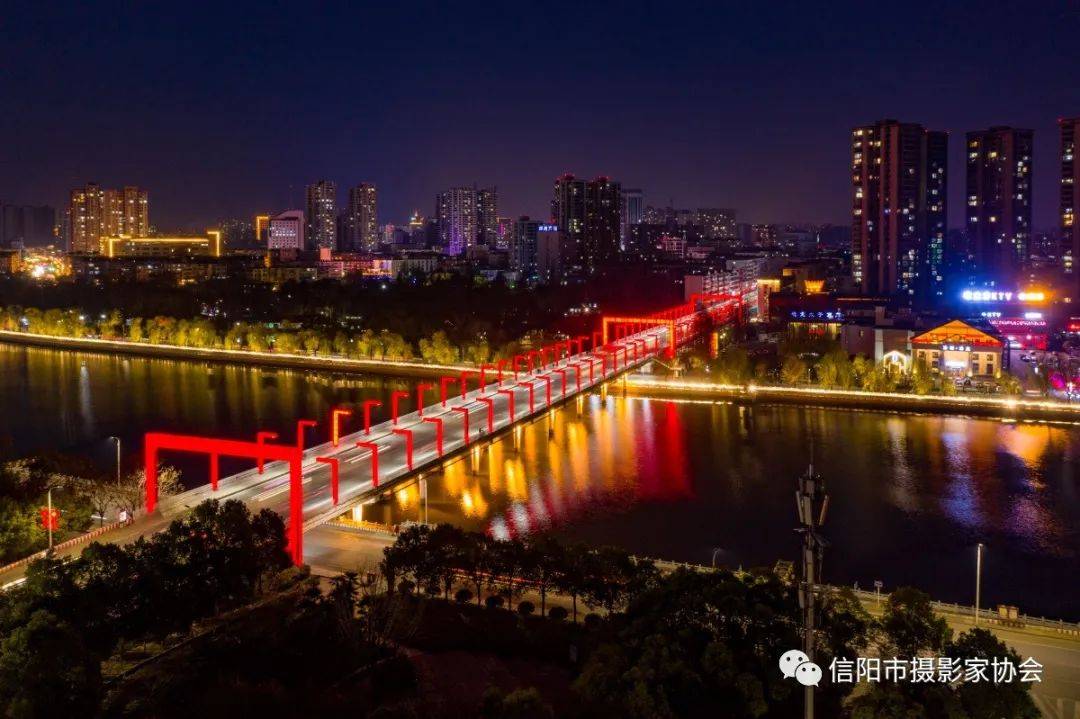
[0,329,472,377]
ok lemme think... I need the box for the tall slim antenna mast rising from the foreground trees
[795,455,828,719]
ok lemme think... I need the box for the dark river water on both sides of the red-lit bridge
[0,344,1080,619]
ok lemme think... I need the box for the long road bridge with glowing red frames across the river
[0,295,743,581]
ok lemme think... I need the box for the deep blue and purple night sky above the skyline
[0,0,1080,229]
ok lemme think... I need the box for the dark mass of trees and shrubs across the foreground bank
[0,501,1037,719]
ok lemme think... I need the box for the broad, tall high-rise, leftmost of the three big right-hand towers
[851,120,948,299]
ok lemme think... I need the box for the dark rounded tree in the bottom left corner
[0,610,102,717]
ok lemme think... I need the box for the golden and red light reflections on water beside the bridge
[369,395,691,537]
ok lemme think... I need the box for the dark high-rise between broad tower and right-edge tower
[966,127,1032,286]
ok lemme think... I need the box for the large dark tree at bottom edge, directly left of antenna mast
[575,570,803,719]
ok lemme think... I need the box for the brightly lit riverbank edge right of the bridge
[624,375,1080,423]
